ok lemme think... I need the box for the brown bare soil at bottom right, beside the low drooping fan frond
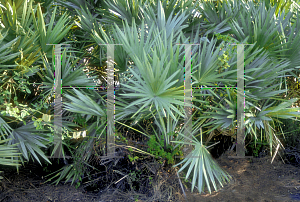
[188,150,300,202]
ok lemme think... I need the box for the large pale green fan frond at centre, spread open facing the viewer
[120,51,184,119]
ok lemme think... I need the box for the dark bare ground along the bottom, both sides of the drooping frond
[0,150,300,202]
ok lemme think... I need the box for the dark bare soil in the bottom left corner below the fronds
[0,165,99,202]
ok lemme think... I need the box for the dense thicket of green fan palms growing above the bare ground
[0,0,300,196]
